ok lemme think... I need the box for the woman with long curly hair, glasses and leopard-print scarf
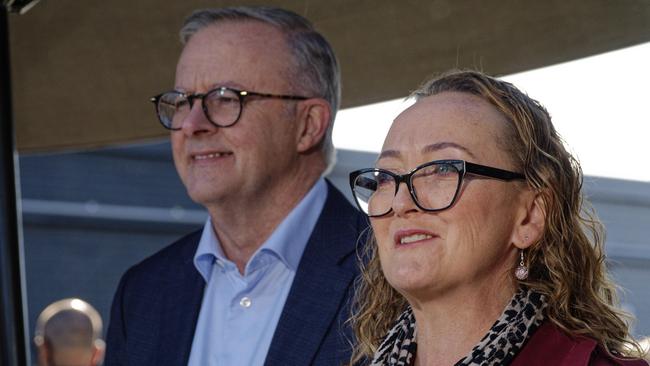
[350,71,646,365]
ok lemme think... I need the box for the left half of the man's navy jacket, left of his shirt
[105,230,204,366]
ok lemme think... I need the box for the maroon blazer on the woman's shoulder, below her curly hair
[510,321,648,366]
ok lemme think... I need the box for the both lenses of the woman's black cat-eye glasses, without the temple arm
[354,163,460,216]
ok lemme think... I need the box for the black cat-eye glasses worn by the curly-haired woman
[350,160,526,217]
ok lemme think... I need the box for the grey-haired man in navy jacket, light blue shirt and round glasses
[107,7,367,366]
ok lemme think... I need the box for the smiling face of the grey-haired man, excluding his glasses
[171,21,299,209]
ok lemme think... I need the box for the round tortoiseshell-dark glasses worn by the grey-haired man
[151,86,309,131]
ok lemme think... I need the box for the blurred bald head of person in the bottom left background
[34,299,104,366]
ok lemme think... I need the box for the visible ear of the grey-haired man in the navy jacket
[296,98,332,153]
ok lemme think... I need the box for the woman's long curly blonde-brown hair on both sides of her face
[350,70,642,364]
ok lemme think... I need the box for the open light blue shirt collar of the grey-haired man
[194,178,327,282]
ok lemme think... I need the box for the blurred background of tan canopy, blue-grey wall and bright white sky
[0,0,650,359]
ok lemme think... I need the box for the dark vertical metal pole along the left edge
[0,5,29,366]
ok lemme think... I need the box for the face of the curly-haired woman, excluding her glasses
[371,92,525,301]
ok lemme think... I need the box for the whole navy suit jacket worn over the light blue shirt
[105,182,368,366]
